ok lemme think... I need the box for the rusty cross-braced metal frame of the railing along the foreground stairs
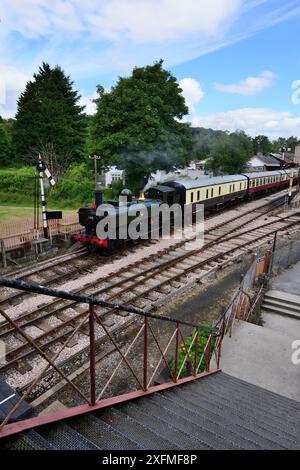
[0,276,218,437]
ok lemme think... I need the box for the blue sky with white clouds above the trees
[0,0,300,139]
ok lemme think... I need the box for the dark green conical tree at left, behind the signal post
[13,63,85,173]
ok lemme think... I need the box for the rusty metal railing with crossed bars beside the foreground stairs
[0,276,221,437]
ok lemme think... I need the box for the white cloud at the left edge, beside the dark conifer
[0,64,32,118]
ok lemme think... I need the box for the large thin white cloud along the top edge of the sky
[0,0,243,43]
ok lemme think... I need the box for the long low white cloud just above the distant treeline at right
[192,108,300,139]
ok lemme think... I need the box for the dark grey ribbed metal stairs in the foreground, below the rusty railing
[0,372,300,450]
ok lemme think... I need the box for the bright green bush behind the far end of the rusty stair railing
[170,323,215,379]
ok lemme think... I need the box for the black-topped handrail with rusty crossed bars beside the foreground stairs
[0,276,221,438]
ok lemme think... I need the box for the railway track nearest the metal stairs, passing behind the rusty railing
[0,191,300,385]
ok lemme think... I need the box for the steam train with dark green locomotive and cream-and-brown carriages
[75,169,300,251]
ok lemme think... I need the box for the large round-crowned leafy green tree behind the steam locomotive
[92,60,193,193]
